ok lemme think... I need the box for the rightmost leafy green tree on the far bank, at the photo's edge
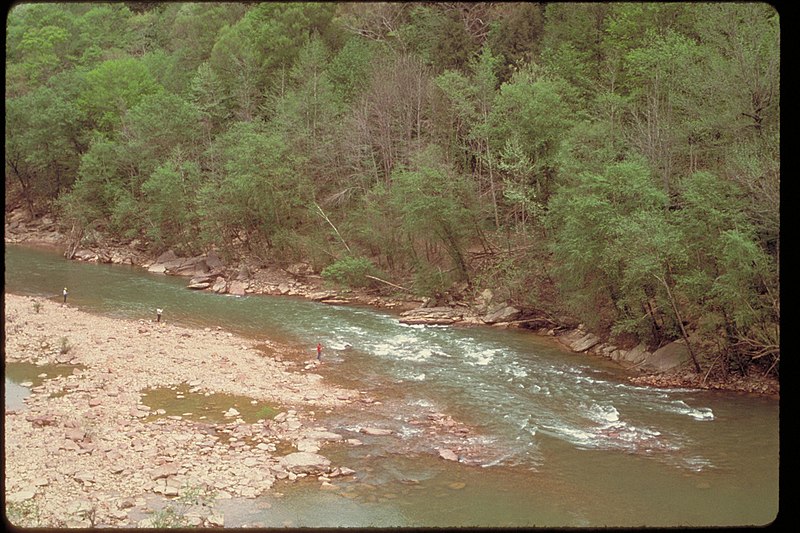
[674,172,780,366]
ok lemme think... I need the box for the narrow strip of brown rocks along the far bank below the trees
[5,209,780,398]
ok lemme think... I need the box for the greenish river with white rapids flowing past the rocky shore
[5,245,779,527]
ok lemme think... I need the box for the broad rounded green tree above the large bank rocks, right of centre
[548,161,680,337]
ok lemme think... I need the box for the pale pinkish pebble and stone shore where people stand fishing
[4,294,361,527]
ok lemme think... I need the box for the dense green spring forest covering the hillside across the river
[5,2,780,375]
